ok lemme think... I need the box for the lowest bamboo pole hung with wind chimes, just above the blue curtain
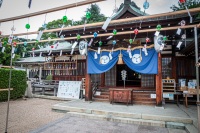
[14,25,197,44]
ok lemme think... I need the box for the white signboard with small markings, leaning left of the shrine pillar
[57,81,81,99]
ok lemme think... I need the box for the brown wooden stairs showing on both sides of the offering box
[93,89,156,105]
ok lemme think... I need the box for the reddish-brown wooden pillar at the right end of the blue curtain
[156,53,163,106]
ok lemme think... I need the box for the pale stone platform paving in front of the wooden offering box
[53,100,197,119]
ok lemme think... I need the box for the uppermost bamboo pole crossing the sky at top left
[0,0,105,23]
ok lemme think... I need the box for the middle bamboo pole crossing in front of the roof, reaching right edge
[3,8,200,37]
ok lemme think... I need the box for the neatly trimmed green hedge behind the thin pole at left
[0,69,27,101]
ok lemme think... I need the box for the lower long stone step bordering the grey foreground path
[68,112,165,127]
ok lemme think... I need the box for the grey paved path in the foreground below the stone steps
[30,116,186,133]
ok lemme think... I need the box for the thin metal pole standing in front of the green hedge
[5,43,13,133]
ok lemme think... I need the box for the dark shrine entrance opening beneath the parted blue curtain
[116,64,141,87]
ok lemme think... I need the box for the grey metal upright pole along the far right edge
[194,26,200,133]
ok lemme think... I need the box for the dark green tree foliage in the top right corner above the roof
[170,0,200,11]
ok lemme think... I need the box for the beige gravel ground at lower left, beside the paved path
[0,98,66,133]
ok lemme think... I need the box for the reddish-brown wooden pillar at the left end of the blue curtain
[85,57,92,101]
